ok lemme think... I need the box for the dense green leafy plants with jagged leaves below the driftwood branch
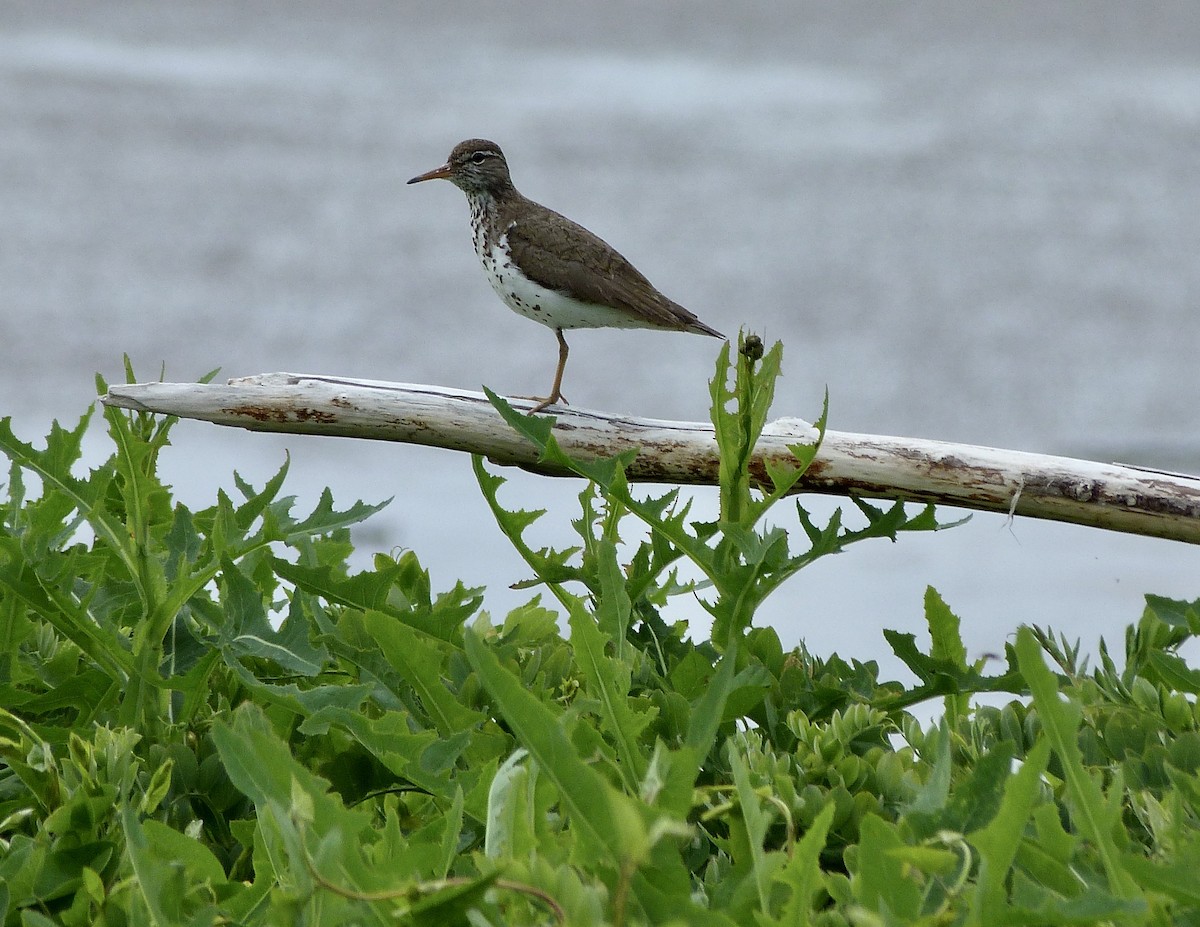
[0,340,1200,927]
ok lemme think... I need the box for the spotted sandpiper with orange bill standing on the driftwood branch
[408,138,725,414]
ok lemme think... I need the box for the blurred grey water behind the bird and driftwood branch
[0,0,1200,668]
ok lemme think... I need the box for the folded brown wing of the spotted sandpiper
[505,202,722,337]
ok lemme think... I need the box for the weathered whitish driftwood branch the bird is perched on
[103,373,1200,544]
